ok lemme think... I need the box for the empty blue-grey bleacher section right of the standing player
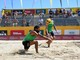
[54,18,79,26]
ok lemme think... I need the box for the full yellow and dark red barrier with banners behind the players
[0,26,80,40]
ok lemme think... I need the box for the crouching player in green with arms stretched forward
[22,26,51,53]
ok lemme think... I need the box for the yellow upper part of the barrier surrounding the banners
[0,26,80,35]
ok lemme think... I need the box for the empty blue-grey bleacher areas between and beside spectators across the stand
[1,16,80,26]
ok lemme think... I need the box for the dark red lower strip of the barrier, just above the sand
[0,35,80,40]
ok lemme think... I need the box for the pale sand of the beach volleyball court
[0,40,80,60]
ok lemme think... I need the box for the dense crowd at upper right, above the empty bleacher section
[49,9,80,18]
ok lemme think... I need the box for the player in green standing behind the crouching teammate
[46,18,57,47]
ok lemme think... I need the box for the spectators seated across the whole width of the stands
[0,9,80,26]
